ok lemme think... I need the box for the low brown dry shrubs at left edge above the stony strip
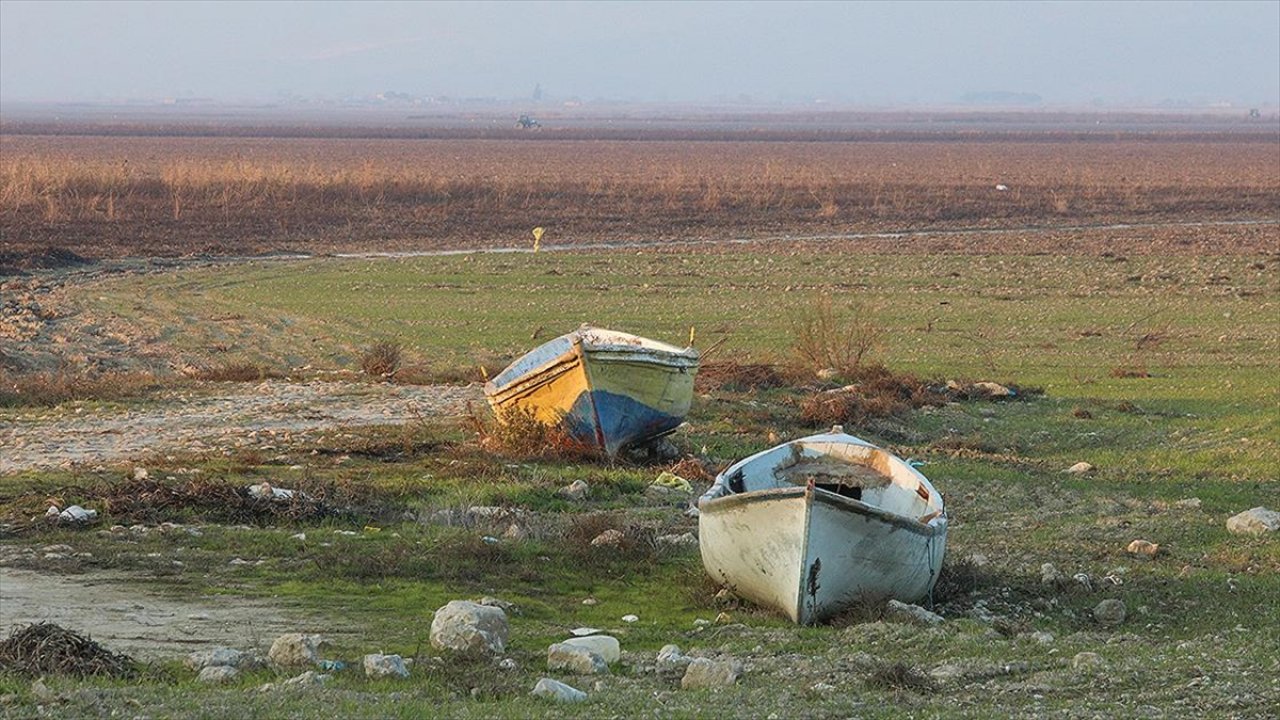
[0,370,163,407]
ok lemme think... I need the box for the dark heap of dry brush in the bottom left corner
[0,623,138,678]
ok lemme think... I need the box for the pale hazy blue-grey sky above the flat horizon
[0,0,1280,106]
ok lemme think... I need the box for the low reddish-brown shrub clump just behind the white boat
[800,365,947,427]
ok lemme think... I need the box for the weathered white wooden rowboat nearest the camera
[698,425,947,624]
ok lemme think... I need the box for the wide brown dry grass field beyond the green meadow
[0,126,1280,266]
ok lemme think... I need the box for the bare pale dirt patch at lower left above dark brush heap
[0,566,332,660]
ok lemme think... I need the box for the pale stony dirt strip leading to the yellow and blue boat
[0,382,483,474]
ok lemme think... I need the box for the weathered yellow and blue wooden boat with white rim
[485,325,698,457]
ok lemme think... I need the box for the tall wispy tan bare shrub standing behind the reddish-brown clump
[791,296,884,378]
